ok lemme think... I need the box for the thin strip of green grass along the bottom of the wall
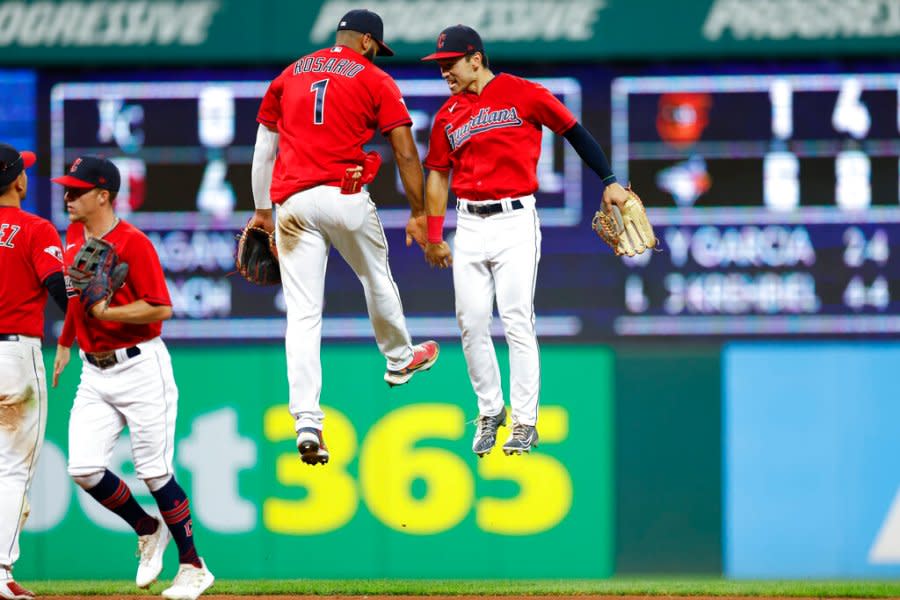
[23,577,900,598]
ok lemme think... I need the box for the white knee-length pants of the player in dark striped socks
[69,338,178,480]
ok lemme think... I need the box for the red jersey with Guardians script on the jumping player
[425,73,577,200]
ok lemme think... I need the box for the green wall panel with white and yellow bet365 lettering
[16,344,615,580]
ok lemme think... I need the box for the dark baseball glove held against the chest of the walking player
[66,238,128,314]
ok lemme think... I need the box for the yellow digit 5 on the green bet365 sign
[475,406,572,535]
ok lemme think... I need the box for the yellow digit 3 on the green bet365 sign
[263,405,359,535]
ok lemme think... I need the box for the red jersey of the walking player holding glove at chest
[59,221,172,352]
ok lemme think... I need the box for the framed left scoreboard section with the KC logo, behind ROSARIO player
[49,71,582,340]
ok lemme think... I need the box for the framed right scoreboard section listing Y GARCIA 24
[611,73,900,336]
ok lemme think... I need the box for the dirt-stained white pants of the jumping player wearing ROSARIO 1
[276,186,413,430]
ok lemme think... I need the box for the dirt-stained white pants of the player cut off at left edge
[0,336,47,567]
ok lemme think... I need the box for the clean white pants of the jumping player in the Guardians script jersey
[453,196,541,425]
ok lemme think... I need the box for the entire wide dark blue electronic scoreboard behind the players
[38,63,900,341]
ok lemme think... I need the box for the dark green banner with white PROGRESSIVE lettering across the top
[0,0,900,67]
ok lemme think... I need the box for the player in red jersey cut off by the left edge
[0,144,67,600]
